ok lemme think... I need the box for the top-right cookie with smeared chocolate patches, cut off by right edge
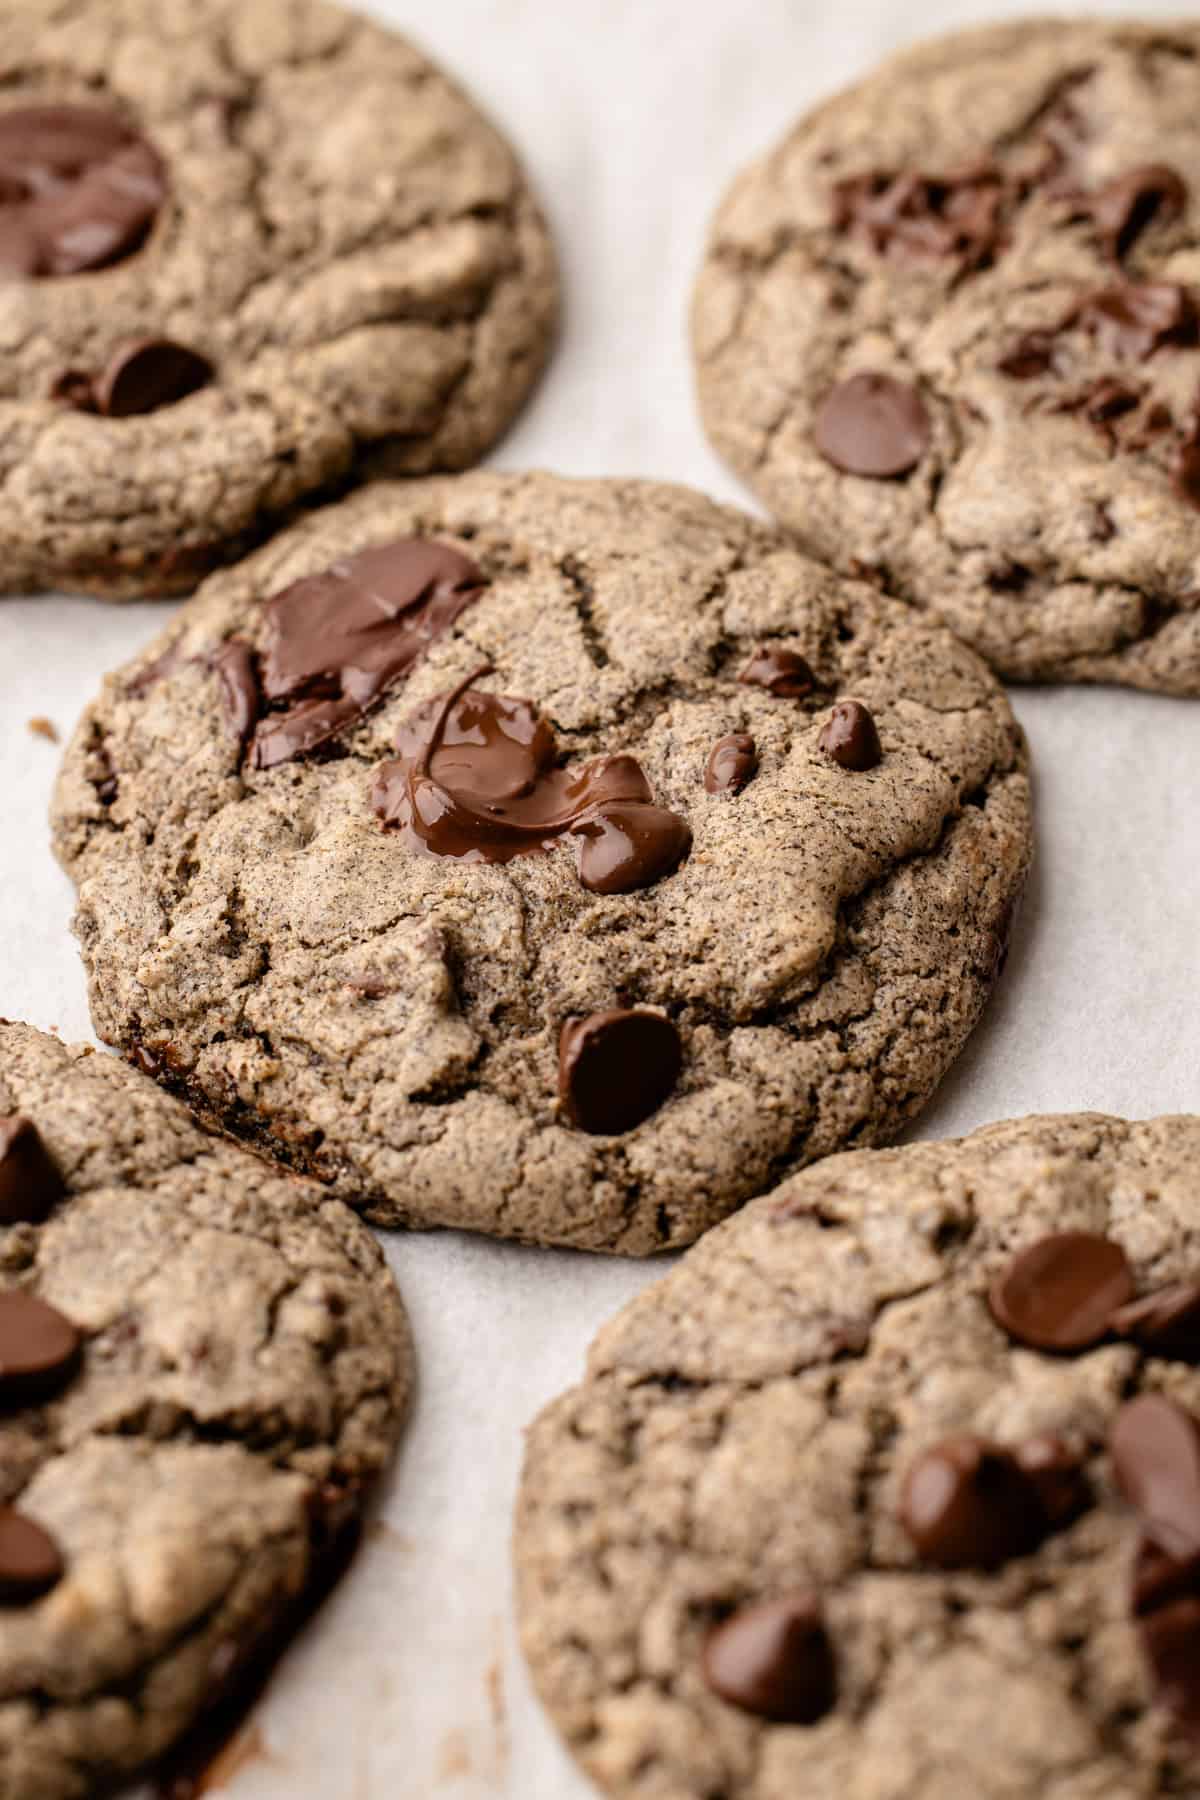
[693,20,1200,695]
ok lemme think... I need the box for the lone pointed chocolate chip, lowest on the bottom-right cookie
[702,1588,837,1724]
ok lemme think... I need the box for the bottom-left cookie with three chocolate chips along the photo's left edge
[0,1022,410,1800]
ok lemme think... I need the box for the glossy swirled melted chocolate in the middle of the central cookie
[371,670,691,895]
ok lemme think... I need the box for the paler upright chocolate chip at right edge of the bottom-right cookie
[1108,1393,1200,1559]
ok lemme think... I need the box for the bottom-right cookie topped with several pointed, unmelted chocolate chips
[516,1114,1200,1800]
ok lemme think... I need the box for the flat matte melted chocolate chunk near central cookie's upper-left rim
[252,538,486,769]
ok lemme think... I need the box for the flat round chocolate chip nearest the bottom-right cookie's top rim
[988,1231,1133,1352]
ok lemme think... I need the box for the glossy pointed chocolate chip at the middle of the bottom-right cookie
[900,1433,1049,1570]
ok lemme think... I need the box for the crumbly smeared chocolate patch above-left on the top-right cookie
[833,164,1006,272]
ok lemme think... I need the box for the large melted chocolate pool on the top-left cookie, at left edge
[0,106,167,279]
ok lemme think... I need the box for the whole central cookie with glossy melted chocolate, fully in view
[54,473,1029,1255]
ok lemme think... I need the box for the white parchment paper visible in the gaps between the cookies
[0,0,1200,1800]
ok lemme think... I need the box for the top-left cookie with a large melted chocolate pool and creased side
[0,0,558,599]
